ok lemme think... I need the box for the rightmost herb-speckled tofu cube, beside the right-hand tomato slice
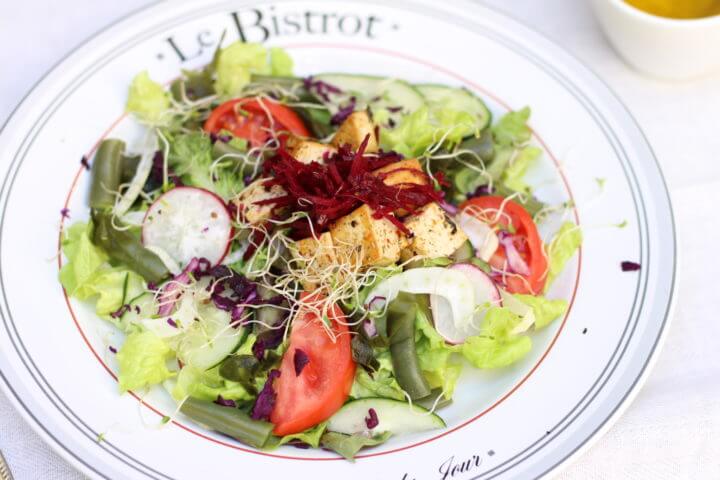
[401,203,468,261]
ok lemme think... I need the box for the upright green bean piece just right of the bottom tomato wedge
[387,293,430,400]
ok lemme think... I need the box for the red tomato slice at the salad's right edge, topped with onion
[460,196,547,295]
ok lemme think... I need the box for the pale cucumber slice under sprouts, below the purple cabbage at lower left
[177,304,246,370]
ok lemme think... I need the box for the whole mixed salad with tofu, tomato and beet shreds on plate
[60,43,582,459]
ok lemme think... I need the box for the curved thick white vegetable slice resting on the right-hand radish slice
[366,267,475,327]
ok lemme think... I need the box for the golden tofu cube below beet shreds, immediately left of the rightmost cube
[330,205,405,267]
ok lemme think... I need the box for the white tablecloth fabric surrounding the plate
[0,0,720,480]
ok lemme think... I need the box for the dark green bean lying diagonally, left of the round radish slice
[92,211,170,283]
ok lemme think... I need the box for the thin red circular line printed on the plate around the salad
[58,43,582,461]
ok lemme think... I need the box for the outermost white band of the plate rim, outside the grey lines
[0,0,680,478]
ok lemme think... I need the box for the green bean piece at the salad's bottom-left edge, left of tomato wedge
[180,398,274,448]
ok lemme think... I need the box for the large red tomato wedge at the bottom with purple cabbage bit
[270,293,355,436]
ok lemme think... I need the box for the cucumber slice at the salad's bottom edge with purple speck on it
[327,398,445,435]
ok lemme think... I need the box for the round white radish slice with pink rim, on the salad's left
[142,187,233,265]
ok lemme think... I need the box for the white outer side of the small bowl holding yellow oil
[592,0,720,80]
